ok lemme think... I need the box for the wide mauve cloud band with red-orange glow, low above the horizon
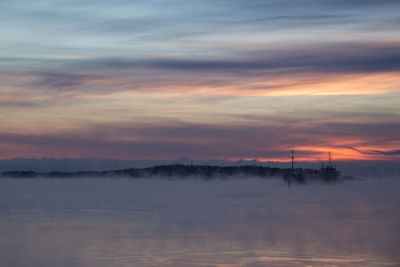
[0,123,400,159]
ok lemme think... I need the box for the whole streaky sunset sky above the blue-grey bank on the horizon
[0,0,400,161]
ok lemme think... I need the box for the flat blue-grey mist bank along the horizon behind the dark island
[0,158,400,177]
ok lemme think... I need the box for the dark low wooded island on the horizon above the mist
[0,164,351,183]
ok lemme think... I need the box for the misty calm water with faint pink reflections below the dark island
[0,177,400,267]
